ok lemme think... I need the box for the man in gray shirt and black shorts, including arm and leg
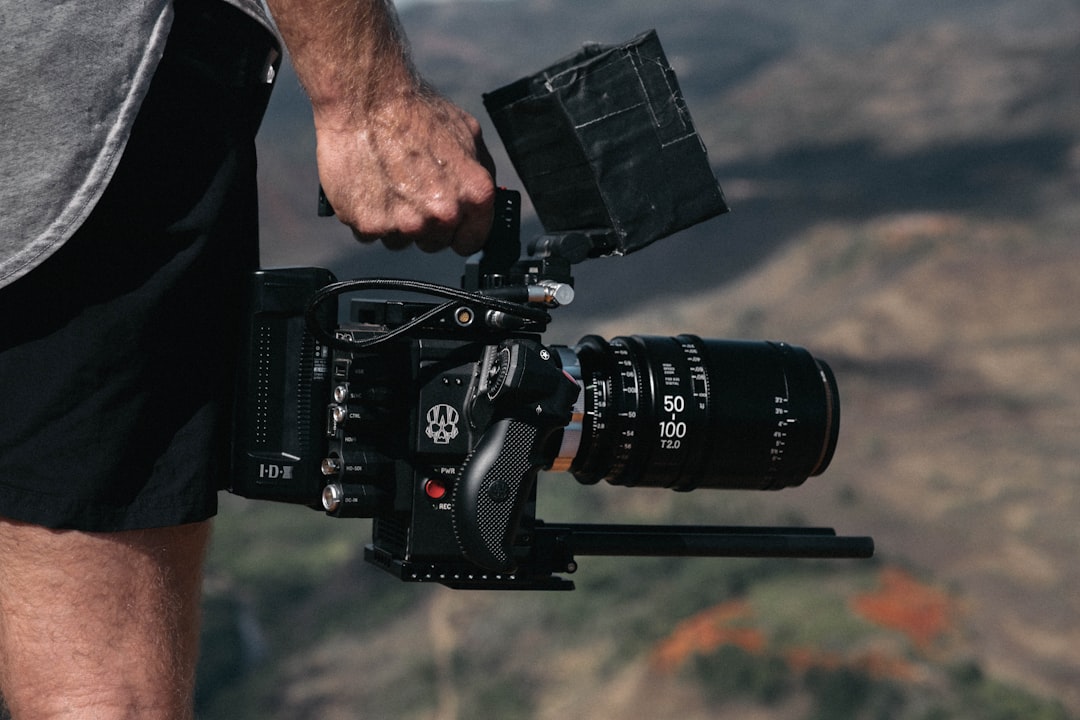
[0,0,495,720]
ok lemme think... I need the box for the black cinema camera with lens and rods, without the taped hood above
[229,191,873,589]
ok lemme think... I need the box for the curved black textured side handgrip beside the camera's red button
[454,418,546,572]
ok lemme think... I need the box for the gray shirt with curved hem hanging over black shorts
[0,0,272,287]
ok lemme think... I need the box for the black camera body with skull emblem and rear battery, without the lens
[230,269,579,584]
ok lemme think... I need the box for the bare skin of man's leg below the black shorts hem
[0,520,210,720]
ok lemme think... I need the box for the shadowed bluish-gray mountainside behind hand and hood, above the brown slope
[254,0,1080,321]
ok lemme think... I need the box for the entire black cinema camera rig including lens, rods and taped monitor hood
[230,32,873,589]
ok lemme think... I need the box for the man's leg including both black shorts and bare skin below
[0,2,273,720]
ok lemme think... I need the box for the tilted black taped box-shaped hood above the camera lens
[484,30,728,256]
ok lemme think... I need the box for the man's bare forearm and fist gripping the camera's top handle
[269,0,495,255]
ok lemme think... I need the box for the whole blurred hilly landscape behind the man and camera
[199,0,1080,720]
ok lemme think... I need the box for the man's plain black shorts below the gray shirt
[0,0,273,531]
